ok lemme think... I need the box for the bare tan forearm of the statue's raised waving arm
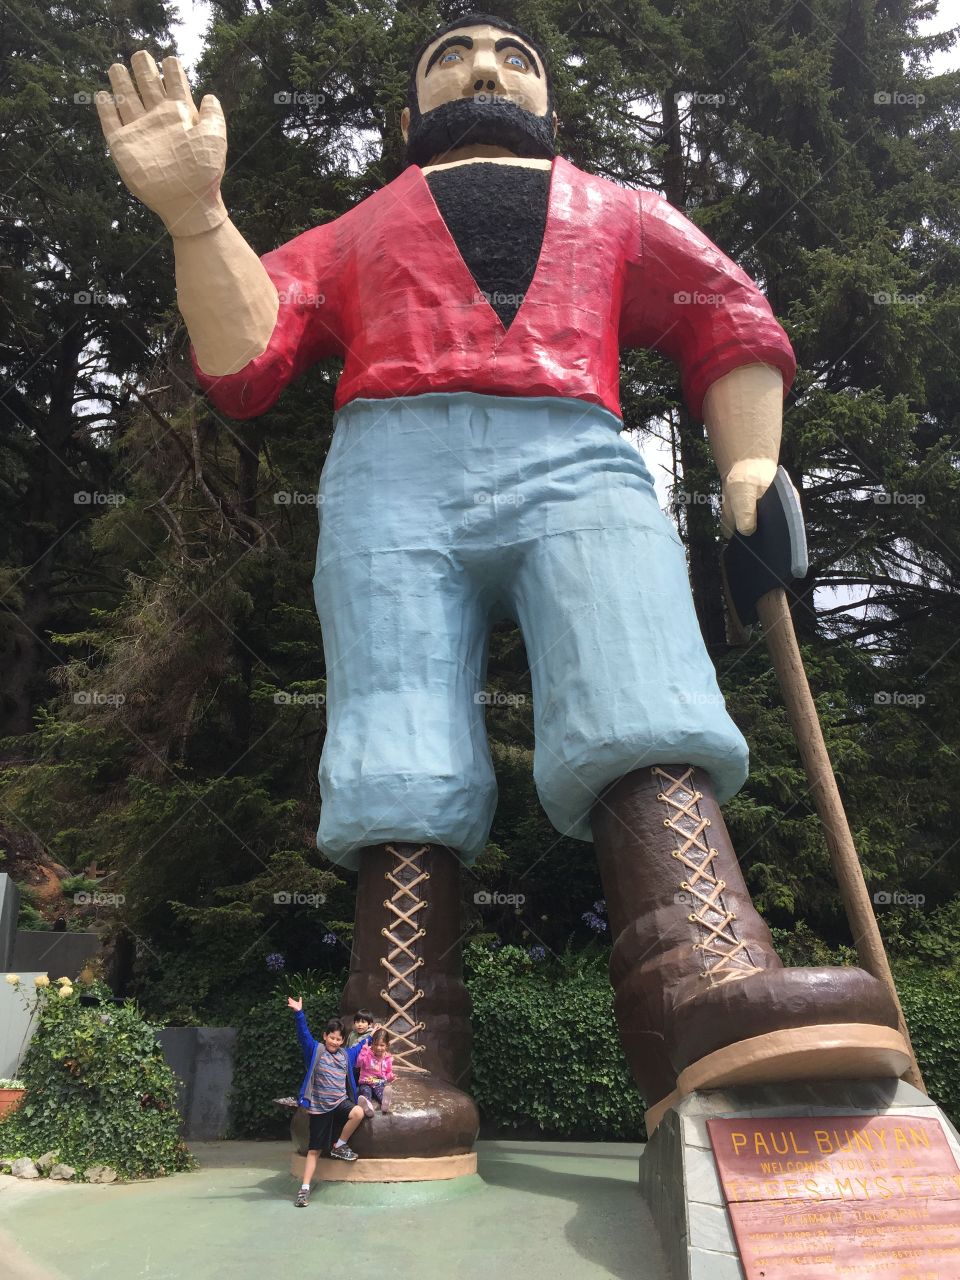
[173,218,279,376]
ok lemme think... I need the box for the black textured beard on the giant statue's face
[407,97,557,166]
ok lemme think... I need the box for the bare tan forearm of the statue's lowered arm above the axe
[703,365,783,477]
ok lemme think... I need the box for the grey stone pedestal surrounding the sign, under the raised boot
[640,1079,960,1280]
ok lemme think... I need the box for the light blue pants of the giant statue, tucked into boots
[314,392,748,868]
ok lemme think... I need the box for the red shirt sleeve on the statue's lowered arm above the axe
[620,191,796,417]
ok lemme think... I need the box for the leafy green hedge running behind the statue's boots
[232,937,960,1142]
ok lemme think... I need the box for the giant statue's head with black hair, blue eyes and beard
[401,20,557,165]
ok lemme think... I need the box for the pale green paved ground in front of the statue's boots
[0,1142,666,1280]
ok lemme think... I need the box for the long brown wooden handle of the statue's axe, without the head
[756,588,927,1093]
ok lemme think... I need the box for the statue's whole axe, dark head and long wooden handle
[721,467,927,1093]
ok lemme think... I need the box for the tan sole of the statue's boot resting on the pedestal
[644,1023,911,1135]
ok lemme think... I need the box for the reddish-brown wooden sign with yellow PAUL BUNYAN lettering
[707,1115,960,1280]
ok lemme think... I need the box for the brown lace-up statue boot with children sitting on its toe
[340,844,480,1158]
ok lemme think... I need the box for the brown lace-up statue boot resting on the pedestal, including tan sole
[591,764,910,1129]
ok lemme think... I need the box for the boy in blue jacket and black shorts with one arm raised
[287,996,379,1208]
